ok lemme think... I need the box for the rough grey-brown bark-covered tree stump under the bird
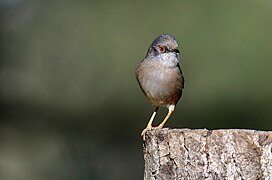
[144,128,272,180]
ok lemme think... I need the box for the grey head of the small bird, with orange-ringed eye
[146,34,179,59]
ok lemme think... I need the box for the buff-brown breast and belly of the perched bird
[137,62,183,106]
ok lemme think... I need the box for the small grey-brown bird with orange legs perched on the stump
[136,34,184,139]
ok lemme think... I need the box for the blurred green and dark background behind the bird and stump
[0,0,272,180]
